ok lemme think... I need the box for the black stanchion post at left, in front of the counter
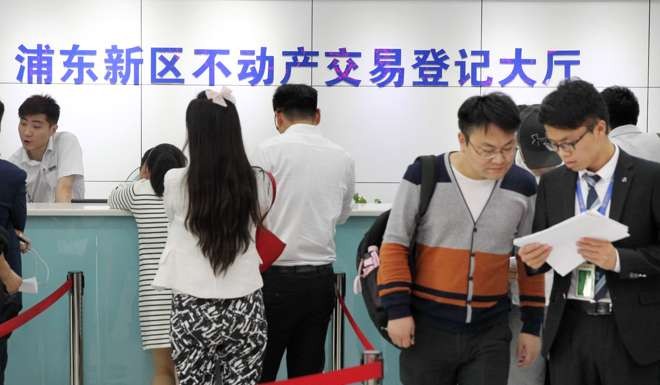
[67,271,85,385]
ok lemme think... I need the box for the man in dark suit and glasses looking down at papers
[519,80,660,385]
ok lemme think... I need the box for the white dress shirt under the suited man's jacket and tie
[568,145,621,302]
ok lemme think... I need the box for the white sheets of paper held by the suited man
[513,210,630,276]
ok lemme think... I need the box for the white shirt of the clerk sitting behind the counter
[9,132,85,202]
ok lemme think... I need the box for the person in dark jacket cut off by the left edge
[0,102,26,385]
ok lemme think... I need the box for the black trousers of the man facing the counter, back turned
[261,265,335,382]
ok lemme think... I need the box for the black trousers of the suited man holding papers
[549,301,660,385]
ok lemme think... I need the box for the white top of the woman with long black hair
[152,168,271,298]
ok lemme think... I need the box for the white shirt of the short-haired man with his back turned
[252,124,355,266]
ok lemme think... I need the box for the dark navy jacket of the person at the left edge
[0,159,26,322]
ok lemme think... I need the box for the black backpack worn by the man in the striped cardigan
[356,155,436,346]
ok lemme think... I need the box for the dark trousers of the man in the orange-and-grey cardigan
[399,316,511,385]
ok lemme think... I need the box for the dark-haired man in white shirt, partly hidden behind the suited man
[600,86,660,162]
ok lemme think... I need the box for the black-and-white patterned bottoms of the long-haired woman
[170,290,267,385]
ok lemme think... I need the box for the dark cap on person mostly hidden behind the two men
[518,104,561,169]
